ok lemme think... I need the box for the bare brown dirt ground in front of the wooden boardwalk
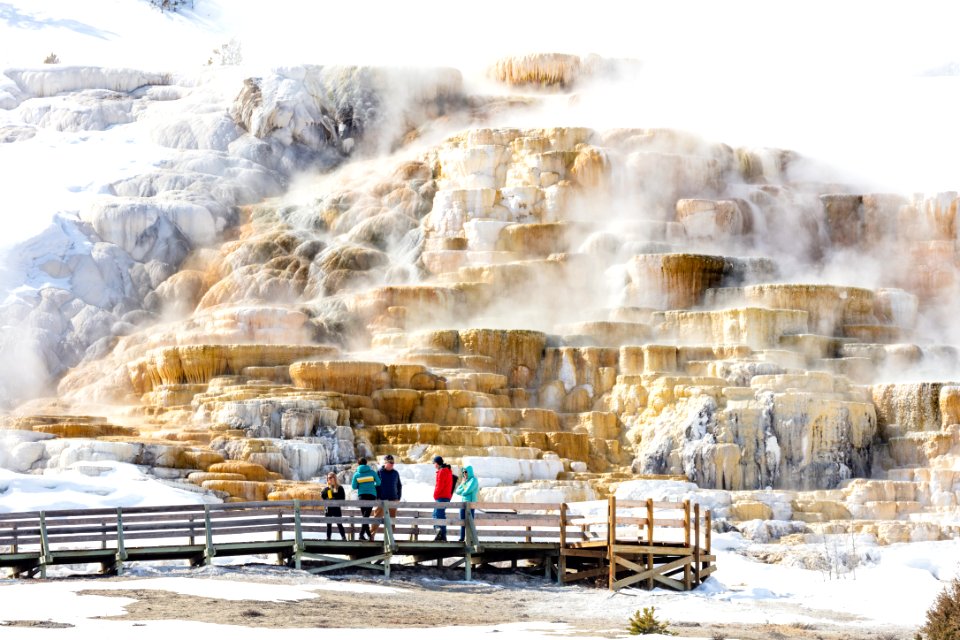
[0,571,913,640]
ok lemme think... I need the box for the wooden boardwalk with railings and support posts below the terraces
[0,498,716,590]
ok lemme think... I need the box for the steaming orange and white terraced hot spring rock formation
[0,54,960,544]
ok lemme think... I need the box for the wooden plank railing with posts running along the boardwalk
[0,496,715,584]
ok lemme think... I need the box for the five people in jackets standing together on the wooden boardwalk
[321,455,480,542]
